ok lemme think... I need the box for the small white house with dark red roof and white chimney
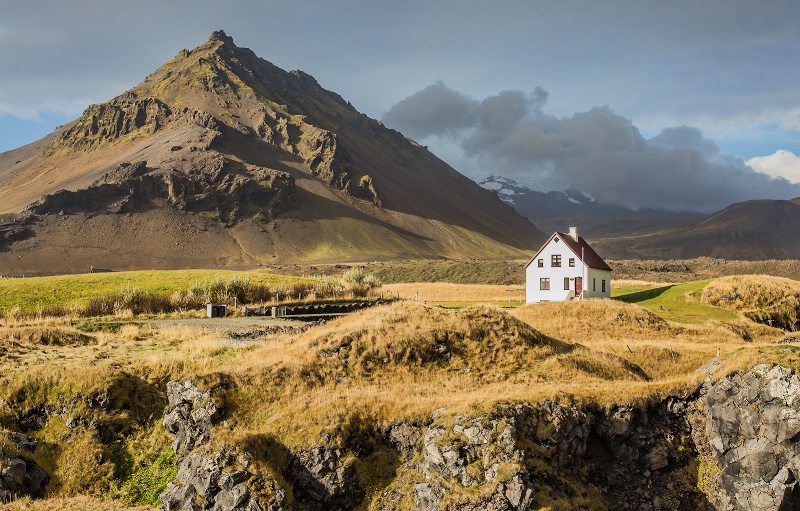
[525,227,611,303]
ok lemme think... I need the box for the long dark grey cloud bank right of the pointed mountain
[383,82,800,212]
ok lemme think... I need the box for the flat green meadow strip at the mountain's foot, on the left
[0,270,311,313]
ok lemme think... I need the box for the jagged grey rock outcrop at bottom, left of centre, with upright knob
[161,381,364,511]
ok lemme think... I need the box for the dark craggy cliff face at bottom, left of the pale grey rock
[386,401,707,511]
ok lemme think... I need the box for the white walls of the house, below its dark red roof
[525,237,611,303]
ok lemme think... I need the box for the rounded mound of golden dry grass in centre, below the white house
[306,302,574,379]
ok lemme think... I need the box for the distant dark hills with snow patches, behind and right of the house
[477,175,800,260]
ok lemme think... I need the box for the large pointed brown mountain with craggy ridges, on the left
[0,32,545,273]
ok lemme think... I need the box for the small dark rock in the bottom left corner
[0,431,50,503]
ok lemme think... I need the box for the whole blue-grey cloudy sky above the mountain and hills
[0,0,800,212]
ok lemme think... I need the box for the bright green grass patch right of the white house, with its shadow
[614,280,739,324]
